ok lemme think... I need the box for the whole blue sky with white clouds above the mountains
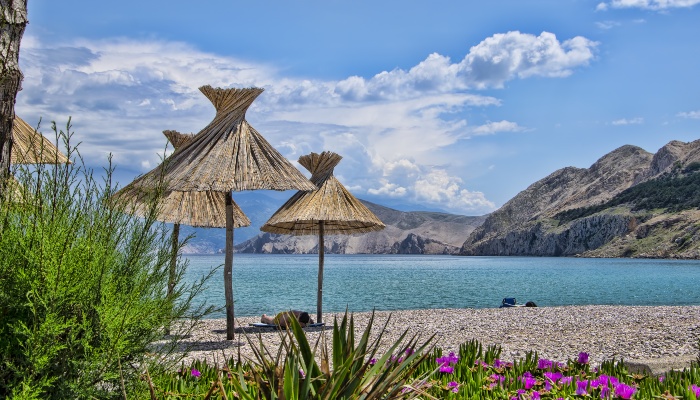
[16,0,700,215]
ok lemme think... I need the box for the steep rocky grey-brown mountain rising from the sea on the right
[460,141,700,258]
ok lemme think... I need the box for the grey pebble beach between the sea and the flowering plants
[159,306,700,373]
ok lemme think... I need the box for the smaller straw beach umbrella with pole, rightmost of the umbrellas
[260,151,384,322]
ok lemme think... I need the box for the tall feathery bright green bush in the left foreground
[0,122,213,399]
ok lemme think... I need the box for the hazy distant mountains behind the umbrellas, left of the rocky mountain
[180,192,485,254]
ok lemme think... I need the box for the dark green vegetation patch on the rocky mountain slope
[554,162,700,224]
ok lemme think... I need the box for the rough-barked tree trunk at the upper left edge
[0,0,27,195]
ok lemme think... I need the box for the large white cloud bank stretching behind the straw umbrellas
[16,28,597,212]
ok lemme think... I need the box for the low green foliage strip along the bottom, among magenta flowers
[142,334,700,400]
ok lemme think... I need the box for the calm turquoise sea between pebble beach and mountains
[185,254,700,318]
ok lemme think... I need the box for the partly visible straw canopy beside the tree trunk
[10,116,70,164]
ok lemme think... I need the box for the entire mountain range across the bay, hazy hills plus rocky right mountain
[182,140,700,259]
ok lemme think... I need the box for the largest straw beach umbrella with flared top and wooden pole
[122,85,315,340]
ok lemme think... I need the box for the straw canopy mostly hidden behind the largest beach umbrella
[114,130,250,228]
